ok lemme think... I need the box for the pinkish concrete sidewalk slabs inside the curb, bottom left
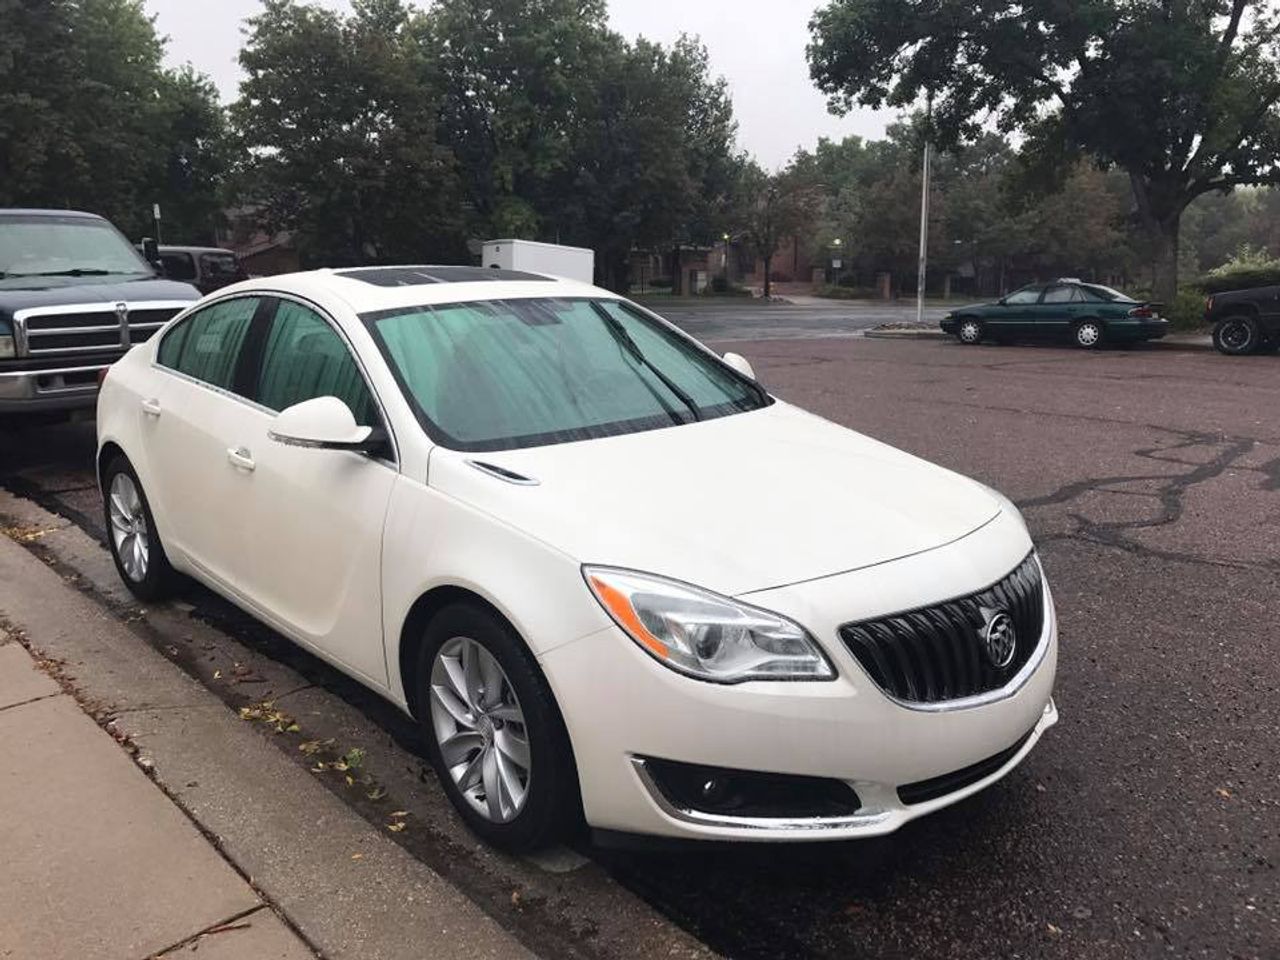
[0,632,316,960]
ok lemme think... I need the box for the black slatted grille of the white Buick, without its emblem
[840,553,1044,703]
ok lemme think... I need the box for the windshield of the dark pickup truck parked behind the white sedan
[0,215,154,285]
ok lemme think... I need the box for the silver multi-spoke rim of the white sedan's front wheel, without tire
[431,636,532,823]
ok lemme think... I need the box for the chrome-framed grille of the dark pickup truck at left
[17,302,188,357]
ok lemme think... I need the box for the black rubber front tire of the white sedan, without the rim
[416,603,581,852]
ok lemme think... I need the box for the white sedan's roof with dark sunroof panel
[220,265,617,314]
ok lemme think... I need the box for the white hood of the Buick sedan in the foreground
[429,402,1001,595]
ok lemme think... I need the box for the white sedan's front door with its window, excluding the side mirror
[227,300,397,686]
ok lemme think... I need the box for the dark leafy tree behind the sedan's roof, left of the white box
[230,0,466,265]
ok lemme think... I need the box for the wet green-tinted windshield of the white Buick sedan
[364,298,772,451]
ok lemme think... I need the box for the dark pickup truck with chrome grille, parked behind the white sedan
[0,210,200,415]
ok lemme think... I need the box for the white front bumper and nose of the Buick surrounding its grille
[543,515,1057,841]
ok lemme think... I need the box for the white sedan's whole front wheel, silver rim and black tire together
[416,603,580,852]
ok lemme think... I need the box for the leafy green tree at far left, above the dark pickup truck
[0,0,221,238]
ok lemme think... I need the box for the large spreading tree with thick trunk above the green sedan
[809,0,1280,302]
